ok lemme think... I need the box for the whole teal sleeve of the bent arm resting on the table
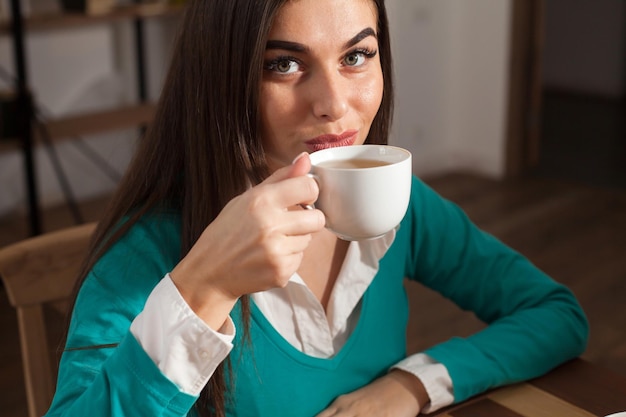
[405,179,588,402]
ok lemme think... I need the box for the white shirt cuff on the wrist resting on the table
[392,353,454,414]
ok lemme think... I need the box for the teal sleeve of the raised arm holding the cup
[46,213,197,417]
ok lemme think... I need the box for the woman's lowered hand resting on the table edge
[317,369,429,417]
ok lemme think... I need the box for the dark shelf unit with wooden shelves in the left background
[0,0,184,235]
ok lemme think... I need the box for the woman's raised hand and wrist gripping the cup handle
[170,154,325,329]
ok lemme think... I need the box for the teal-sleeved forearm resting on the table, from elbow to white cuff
[426,284,588,402]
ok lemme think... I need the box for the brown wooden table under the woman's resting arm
[432,359,626,417]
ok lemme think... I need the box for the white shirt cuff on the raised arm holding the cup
[130,274,235,396]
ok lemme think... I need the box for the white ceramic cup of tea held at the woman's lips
[310,145,412,240]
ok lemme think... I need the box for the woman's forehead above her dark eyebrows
[269,0,378,44]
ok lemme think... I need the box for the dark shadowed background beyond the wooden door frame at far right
[534,0,626,189]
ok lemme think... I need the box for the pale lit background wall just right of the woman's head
[388,0,511,177]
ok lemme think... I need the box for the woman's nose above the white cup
[310,69,350,121]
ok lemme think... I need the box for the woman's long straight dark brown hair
[70,0,393,417]
